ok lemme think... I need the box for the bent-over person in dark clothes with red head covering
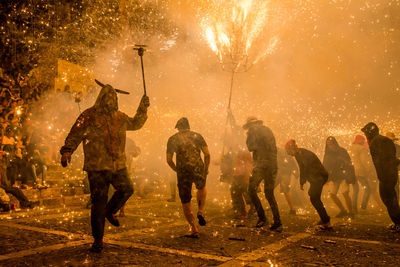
[285,140,332,230]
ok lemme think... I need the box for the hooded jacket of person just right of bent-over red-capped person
[323,136,356,184]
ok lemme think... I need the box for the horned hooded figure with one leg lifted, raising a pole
[60,82,150,252]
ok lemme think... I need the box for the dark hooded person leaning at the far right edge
[361,122,400,231]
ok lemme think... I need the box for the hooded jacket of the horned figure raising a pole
[60,85,147,171]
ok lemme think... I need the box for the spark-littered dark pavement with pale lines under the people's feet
[0,195,400,266]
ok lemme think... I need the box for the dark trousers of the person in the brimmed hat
[249,167,281,223]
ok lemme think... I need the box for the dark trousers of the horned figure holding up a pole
[88,169,133,240]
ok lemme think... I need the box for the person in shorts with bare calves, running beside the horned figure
[167,117,210,238]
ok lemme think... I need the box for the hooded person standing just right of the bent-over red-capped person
[323,136,358,218]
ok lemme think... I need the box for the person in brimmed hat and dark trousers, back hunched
[243,117,282,232]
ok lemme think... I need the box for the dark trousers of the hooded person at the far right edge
[379,179,400,224]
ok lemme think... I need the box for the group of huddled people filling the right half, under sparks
[221,114,400,231]
